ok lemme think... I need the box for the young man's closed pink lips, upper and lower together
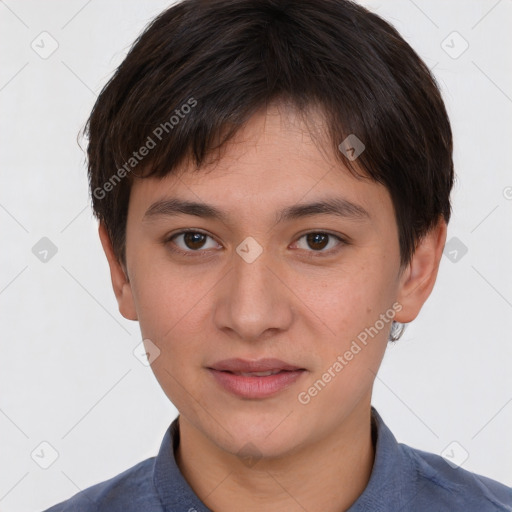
[208,359,306,399]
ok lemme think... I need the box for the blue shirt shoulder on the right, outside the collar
[399,443,512,512]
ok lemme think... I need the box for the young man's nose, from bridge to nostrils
[214,241,293,342]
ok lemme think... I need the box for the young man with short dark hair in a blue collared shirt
[43,0,512,512]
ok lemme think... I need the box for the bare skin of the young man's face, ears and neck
[99,101,446,512]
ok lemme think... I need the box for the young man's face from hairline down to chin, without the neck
[103,103,442,456]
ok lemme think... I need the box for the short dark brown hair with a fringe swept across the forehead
[85,0,454,265]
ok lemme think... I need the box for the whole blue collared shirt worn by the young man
[46,407,512,512]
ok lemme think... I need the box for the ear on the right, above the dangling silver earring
[395,217,447,323]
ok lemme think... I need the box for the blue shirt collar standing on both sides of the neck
[153,406,415,512]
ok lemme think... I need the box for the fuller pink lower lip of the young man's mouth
[209,368,305,398]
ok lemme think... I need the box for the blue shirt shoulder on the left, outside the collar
[41,457,160,512]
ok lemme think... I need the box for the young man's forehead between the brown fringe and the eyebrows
[130,105,392,226]
